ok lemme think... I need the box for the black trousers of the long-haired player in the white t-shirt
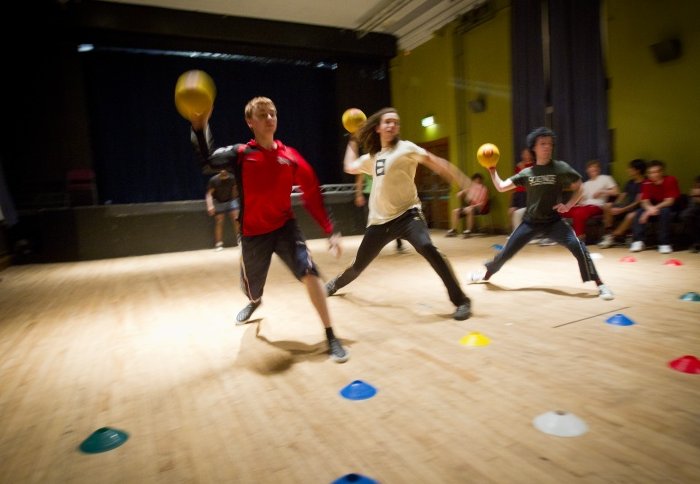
[333,208,469,306]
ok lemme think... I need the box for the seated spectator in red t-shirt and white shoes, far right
[630,160,680,254]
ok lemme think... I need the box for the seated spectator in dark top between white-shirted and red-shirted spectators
[598,159,647,249]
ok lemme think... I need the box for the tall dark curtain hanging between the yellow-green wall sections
[512,0,610,174]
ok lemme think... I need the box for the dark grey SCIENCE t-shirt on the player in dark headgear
[510,160,581,223]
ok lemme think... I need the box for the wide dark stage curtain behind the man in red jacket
[83,49,342,203]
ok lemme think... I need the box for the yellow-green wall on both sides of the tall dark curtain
[391,0,700,233]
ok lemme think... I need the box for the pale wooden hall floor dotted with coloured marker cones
[0,231,700,484]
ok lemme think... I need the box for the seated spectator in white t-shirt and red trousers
[561,160,620,242]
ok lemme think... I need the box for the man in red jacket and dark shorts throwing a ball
[190,97,349,363]
